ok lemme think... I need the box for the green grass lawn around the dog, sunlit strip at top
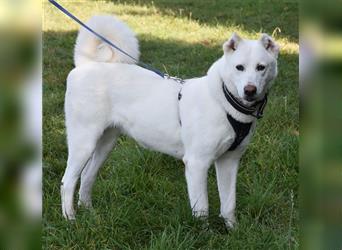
[43,0,299,249]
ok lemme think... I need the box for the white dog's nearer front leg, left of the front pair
[184,157,210,218]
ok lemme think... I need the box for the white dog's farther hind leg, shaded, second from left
[78,128,120,208]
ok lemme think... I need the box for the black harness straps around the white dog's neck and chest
[222,82,267,151]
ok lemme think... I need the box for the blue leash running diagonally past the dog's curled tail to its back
[49,0,167,78]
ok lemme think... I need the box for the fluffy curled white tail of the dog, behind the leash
[74,16,140,67]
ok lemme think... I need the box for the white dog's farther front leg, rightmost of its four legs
[215,152,240,228]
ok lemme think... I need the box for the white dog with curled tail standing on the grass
[61,16,279,227]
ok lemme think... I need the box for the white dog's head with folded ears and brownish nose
[221,33,279,103]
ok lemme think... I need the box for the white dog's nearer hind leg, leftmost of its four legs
[61,124,103,220]
